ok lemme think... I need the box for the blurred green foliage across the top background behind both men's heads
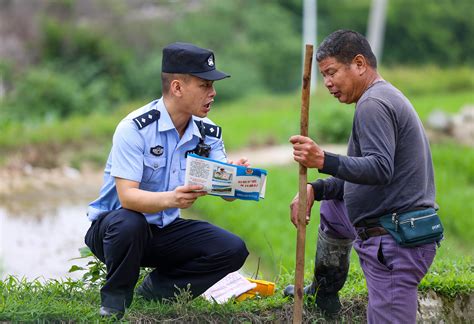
[0,0,474,123]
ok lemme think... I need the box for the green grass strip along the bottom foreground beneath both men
[0,260,474,323]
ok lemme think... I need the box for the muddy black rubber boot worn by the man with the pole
[283,229,352,315]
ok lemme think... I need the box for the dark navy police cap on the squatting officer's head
[161,43,230,81]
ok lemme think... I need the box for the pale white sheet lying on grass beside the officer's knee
[202,271,257,304]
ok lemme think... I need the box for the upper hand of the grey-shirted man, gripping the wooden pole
[290,135,324,169]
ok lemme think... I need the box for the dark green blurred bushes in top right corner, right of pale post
[384,0,474,66]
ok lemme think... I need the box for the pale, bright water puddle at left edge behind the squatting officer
[0,202,90,280]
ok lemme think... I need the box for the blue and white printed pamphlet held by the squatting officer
[184,154,267,201]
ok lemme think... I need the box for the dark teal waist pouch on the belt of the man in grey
[380,208,443,247]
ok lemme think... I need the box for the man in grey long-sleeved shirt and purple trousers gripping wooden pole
[285,30,436,323]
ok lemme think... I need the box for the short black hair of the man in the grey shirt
[316,29,377,69]
